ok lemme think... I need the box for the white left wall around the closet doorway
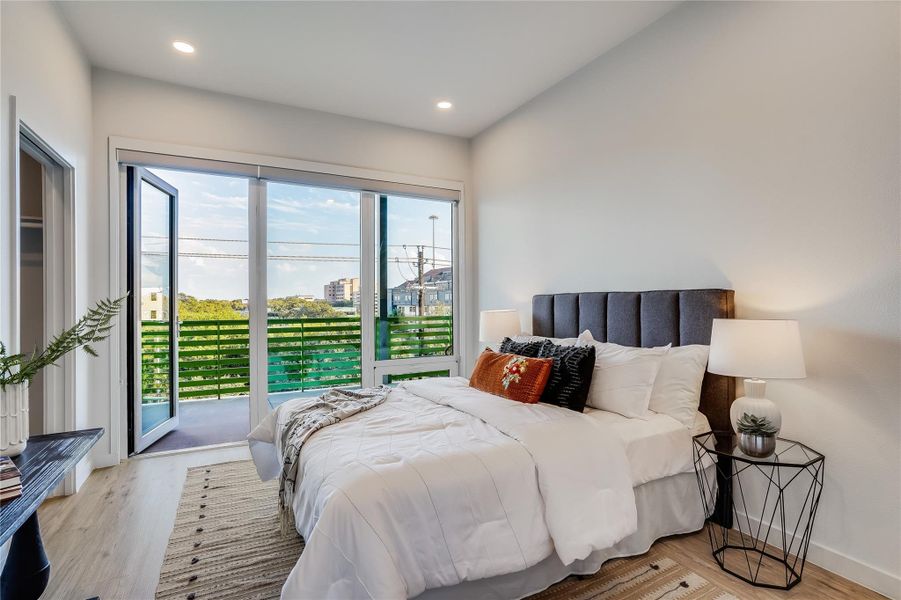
[0,2,94,483]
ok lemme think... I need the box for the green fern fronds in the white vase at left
[0,294,128,389]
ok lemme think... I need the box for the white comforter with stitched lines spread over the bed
[249,378,637,600]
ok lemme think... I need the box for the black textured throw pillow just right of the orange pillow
[538,343,595,412]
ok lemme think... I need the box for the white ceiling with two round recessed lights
[57,1,676,137]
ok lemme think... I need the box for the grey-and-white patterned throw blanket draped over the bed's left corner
[276,386,390,535]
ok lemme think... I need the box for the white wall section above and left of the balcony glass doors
[90,69,469,466]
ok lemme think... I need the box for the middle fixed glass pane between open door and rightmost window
[266,182,362,408]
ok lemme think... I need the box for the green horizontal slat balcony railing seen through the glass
[141,316,453,401]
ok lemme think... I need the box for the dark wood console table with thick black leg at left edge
[0,428,103,600]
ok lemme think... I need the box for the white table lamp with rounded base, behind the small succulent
[707,319,807,433]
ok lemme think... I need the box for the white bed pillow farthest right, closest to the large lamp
[648,344,710,428]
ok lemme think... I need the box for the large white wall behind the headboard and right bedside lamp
[472,3,901,596]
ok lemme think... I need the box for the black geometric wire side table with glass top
[693,433,826,590]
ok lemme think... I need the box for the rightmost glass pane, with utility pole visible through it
[375,195,457,383]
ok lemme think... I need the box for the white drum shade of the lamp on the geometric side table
[707,319,807,379]
